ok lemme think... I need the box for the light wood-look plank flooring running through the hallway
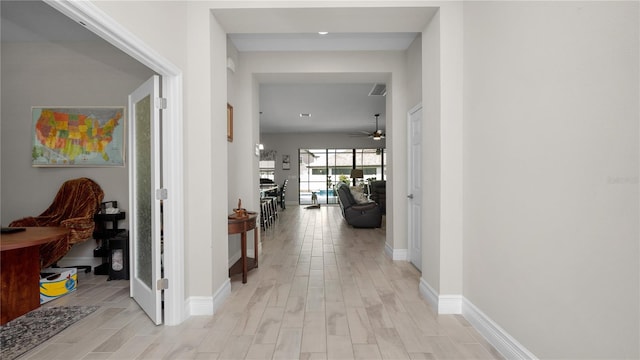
[23,206,502,360]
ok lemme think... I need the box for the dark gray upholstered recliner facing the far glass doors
[336,183,382,228]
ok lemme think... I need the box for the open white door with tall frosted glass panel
[128,75,162,325]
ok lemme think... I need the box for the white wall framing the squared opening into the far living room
[228,52,408,256]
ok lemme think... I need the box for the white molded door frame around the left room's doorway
[44,0,189,325]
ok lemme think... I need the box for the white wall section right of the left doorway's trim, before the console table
[91,1,222,314]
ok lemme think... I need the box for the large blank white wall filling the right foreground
[464,2,640,359]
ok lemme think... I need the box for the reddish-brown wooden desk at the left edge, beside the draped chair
[0,227,69,325]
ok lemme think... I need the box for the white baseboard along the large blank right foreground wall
[462,297,538,360]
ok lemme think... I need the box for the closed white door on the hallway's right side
[407,105,422,271]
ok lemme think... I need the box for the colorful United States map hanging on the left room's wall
[31,106,126,167]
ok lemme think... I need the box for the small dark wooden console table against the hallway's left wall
[228,212,258,284]
